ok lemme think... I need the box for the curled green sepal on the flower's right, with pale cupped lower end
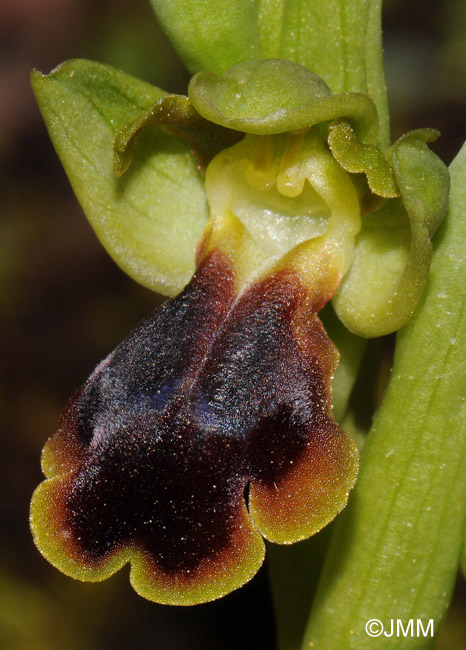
[333,129,449,337]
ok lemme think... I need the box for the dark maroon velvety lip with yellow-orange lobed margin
[31,250,357,605]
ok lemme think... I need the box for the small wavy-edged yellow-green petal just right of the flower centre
[328,120,400,199]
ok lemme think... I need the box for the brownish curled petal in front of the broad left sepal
[114,95,241,177]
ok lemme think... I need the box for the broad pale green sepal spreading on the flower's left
[32,60,207,295]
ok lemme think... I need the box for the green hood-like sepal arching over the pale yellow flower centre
[188,59,378,142]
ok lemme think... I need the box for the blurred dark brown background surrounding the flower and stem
[0,0,466,650]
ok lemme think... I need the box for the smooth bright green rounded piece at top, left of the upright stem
[150,0,260,74]
